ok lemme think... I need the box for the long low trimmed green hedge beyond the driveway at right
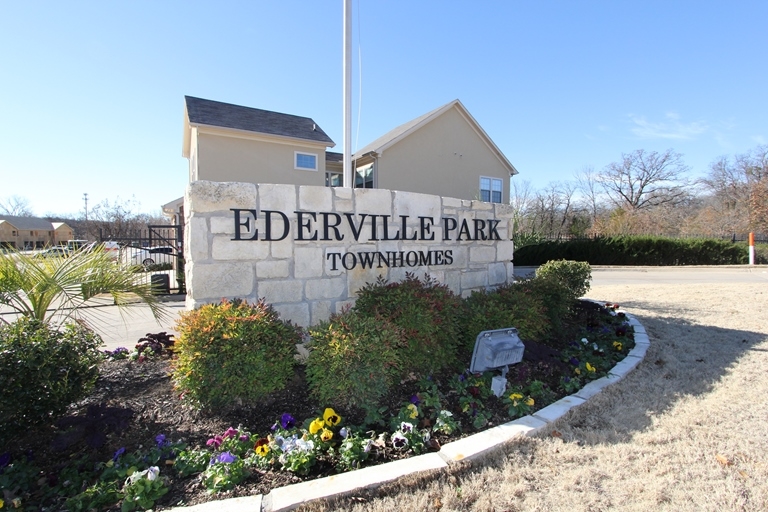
[515,236,749,266]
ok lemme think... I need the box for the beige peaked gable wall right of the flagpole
[376,109,509,203]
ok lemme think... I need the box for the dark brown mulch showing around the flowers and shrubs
[3,300,616,509]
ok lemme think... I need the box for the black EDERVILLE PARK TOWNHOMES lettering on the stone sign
[231,208,501,270]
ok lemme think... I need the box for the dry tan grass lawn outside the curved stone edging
[304,284,768,512]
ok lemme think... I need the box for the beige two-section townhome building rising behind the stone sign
[172,96,517,212]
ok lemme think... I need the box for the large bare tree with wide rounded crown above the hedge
[596,149,689,211]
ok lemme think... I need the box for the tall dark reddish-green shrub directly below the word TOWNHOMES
[354,273,461,377]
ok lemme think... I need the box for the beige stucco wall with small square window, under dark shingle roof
[196,132,325,186]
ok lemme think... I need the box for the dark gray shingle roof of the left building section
[184,96,335,146]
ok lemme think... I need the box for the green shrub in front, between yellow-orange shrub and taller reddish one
[306,311,400,407]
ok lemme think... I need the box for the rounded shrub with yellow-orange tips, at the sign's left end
[173,299,301,409]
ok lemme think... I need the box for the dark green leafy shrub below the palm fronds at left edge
[0,317,102,446]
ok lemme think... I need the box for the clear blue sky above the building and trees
[0,0,768,215]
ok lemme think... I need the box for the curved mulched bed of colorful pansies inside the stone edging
[0,302,634,511]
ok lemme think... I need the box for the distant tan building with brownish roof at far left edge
[0,215,74,249]
